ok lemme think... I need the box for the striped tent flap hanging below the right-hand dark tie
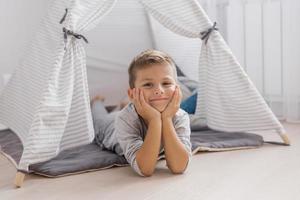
[196,32,285,133]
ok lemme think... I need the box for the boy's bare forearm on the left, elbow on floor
[136,118,162,176]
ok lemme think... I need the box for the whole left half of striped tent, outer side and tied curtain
[0,0,115,171]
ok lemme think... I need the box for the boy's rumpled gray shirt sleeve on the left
[115,114,144,176]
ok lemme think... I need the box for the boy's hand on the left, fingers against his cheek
[132,88,161,123]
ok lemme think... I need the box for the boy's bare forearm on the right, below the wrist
[162,118,189,174]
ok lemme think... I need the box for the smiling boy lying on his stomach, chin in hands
[91,50,191,176]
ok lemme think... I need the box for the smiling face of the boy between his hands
[128,64,176,112]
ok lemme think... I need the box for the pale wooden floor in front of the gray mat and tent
[0,124,300,200]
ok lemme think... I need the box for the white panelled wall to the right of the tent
[225,0,300,121]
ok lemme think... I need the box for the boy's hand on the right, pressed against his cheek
[161,85,182,119]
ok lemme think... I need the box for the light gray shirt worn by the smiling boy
[114,103,192,176]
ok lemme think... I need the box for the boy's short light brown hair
[128,49,177,89]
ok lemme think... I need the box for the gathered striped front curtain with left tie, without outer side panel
[19,1,114,169]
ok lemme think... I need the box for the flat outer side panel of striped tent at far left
[0,1,68,144]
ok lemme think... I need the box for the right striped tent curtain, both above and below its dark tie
[142,0,285,135]
